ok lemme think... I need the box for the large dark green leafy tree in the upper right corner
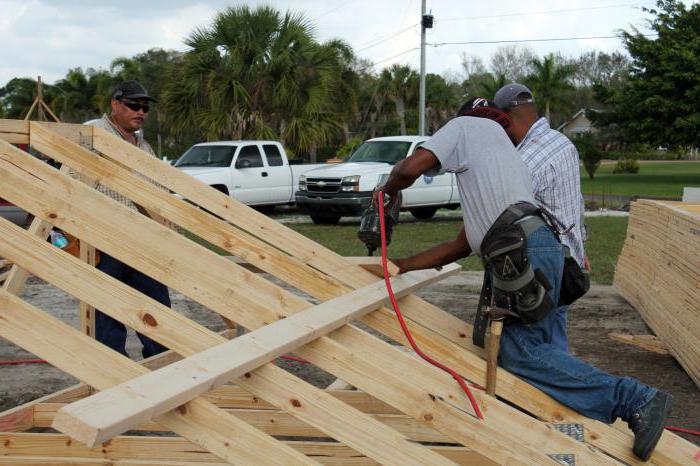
[595,0,700,148]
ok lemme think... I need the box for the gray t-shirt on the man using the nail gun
[422,117,535,255]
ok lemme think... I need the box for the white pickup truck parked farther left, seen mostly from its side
[174,141,324,212]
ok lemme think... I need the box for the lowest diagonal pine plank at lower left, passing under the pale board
[0,290,316,464]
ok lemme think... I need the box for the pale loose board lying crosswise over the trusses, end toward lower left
[53,264,460,446]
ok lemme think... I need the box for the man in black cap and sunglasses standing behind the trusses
[86,80,170,358]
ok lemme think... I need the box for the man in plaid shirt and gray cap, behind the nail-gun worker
[494,83,590,351]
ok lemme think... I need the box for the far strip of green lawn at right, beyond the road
[581,162,700,199]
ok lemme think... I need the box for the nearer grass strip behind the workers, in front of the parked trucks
[291,217,627,284]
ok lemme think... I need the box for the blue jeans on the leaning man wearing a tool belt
[498,227,656,423]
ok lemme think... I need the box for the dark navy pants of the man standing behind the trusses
[95,252,170,358]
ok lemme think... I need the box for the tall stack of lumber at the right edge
[614,200,700,386]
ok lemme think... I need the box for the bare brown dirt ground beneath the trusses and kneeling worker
[0,272,700,445]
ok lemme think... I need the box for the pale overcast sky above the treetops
[0,0,697,86]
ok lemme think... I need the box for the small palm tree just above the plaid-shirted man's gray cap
[525,53,575,120]
